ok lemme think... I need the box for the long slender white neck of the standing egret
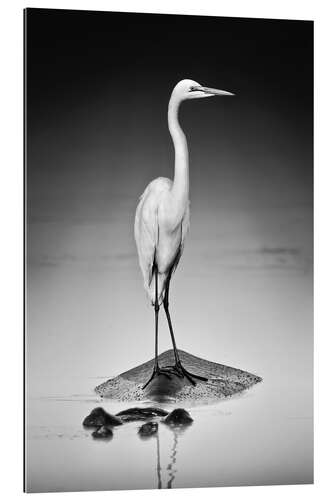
[168,96,189,206]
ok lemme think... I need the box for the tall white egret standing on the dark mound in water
[134,80,234,388]
